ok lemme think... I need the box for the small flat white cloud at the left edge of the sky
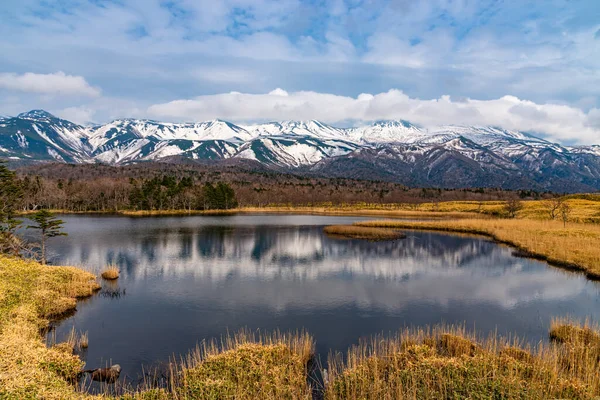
[0,71,100,97]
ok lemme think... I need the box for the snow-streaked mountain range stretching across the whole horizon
[0,110,600,192]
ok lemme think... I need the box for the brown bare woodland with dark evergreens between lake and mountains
[11,163,552,212]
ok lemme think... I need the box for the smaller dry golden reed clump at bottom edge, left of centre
[173,331,314,399]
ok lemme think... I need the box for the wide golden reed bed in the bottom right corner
[325,327,600,399]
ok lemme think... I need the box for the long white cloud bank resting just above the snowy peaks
[147,89,600,143]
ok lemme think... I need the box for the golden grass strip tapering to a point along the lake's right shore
[355,219,600,279]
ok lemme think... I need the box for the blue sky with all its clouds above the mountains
[0,0,600,144]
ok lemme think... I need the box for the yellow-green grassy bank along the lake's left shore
[0,256,99,399]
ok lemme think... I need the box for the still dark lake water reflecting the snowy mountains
[43,215,600,382]
